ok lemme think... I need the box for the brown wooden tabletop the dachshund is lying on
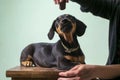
[6,66,64,80]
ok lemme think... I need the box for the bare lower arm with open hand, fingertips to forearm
[58,64,120,80]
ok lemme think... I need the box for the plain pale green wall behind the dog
[0,0,108,80]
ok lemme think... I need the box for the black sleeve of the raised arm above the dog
[71,0,120,19]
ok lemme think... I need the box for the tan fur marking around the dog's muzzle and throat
[56,23,76,43]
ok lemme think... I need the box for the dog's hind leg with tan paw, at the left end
[20,45,34,67]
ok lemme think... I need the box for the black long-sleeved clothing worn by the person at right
[71,0,120,80]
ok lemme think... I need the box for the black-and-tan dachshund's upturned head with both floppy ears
[48,14,86,43]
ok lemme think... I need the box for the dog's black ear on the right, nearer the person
[76,19,87,36]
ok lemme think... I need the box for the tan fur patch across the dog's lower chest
[64,55,85,64]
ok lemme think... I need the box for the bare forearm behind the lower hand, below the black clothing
[93,65,120,79]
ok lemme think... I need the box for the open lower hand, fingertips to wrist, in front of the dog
[58,64,98,80]
